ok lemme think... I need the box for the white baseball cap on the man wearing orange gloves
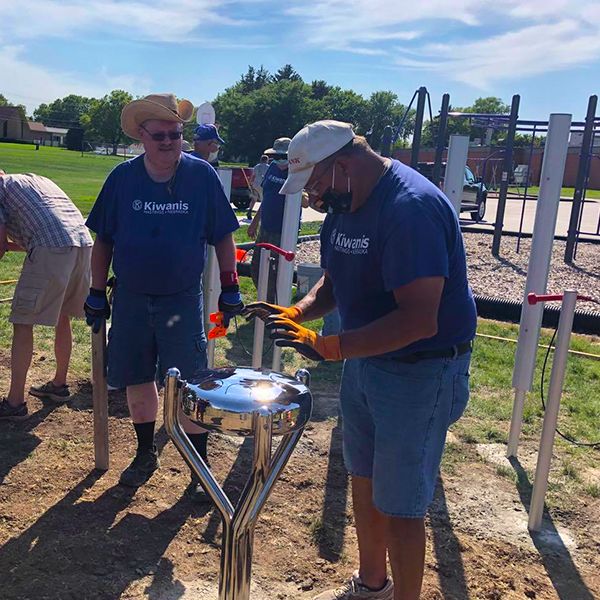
[279,120,354,194]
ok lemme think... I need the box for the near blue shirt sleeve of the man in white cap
[381,203,449,291]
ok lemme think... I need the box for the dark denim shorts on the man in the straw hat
[107,284,206,388]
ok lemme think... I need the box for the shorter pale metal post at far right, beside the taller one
[529,290,577,531]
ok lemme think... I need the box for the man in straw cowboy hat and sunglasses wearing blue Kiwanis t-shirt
[85,94,243,492]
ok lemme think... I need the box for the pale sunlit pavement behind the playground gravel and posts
[240,194,600,235]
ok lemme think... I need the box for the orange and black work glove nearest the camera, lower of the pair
[265,317,342,360]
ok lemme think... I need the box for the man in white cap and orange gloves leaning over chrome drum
[245,121,476,600]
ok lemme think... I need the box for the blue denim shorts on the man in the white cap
[340,352,471,518]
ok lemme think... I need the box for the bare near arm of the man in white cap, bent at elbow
[340,277,445,358]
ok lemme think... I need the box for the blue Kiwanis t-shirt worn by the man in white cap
[321,161,477,356]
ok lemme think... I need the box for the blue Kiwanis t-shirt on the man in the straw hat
[87,154,238,295]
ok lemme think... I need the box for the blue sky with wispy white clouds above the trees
[0,0,600,120]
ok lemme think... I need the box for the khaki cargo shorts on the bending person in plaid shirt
[9,246,92,327]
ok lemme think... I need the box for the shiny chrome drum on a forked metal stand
[164,367,312,600]
